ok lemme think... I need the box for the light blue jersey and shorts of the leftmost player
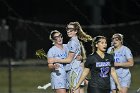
[47,44,68,89]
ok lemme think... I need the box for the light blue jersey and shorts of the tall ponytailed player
[67,37,83,87]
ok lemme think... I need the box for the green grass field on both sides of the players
[0,59,140,93]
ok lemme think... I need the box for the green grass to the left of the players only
[0,66,52,93]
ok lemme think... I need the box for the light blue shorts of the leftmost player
[51,64,67,89]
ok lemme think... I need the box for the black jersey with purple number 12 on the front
[85,53,114,89]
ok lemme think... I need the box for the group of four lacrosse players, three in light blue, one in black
[47,22,134,93]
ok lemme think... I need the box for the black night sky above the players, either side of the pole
[0,0,140,24]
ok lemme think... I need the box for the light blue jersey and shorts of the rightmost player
[107,46,133,89]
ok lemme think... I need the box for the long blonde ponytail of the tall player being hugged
[68,22,92,42]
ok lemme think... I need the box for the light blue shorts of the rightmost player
[110,69,131,90]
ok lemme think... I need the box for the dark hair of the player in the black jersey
[91,36,106,53]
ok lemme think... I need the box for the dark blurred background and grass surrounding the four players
[0,0,140,93]
